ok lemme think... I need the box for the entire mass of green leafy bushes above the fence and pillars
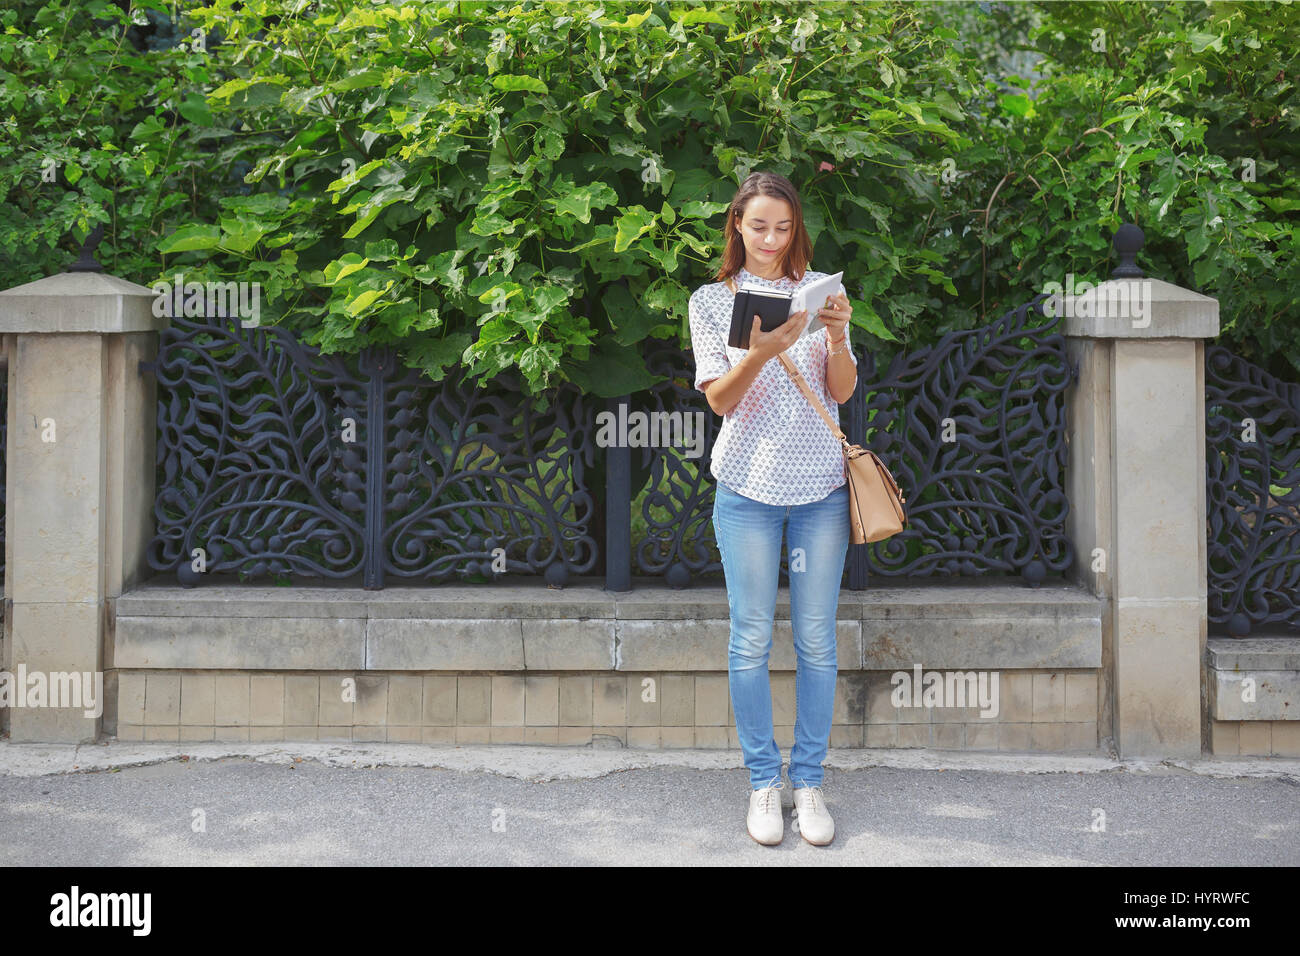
[0,0,1300,395]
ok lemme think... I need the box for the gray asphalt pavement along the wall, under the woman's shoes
[0,743,1300,866]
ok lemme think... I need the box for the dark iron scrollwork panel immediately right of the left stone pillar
[148,316,368,584]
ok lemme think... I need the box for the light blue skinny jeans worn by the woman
[714,481,849,790]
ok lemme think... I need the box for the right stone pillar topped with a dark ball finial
[1058,225,1218,757]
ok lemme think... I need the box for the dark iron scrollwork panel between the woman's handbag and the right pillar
[850,295,1074,585]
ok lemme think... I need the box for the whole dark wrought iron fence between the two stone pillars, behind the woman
[148,297,1074,591]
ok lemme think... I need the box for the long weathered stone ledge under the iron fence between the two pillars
[112,581,1102,672]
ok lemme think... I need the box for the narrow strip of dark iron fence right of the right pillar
[1205,345,1300,637]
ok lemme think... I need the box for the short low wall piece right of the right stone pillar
[1205,636,1300,721]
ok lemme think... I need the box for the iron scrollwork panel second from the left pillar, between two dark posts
[384,371,601,585]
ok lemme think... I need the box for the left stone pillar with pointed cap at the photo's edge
[0,265,168,743]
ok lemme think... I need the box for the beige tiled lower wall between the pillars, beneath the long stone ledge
[105,670,1099,753]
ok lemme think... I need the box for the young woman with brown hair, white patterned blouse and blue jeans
[689,173,858,845]
